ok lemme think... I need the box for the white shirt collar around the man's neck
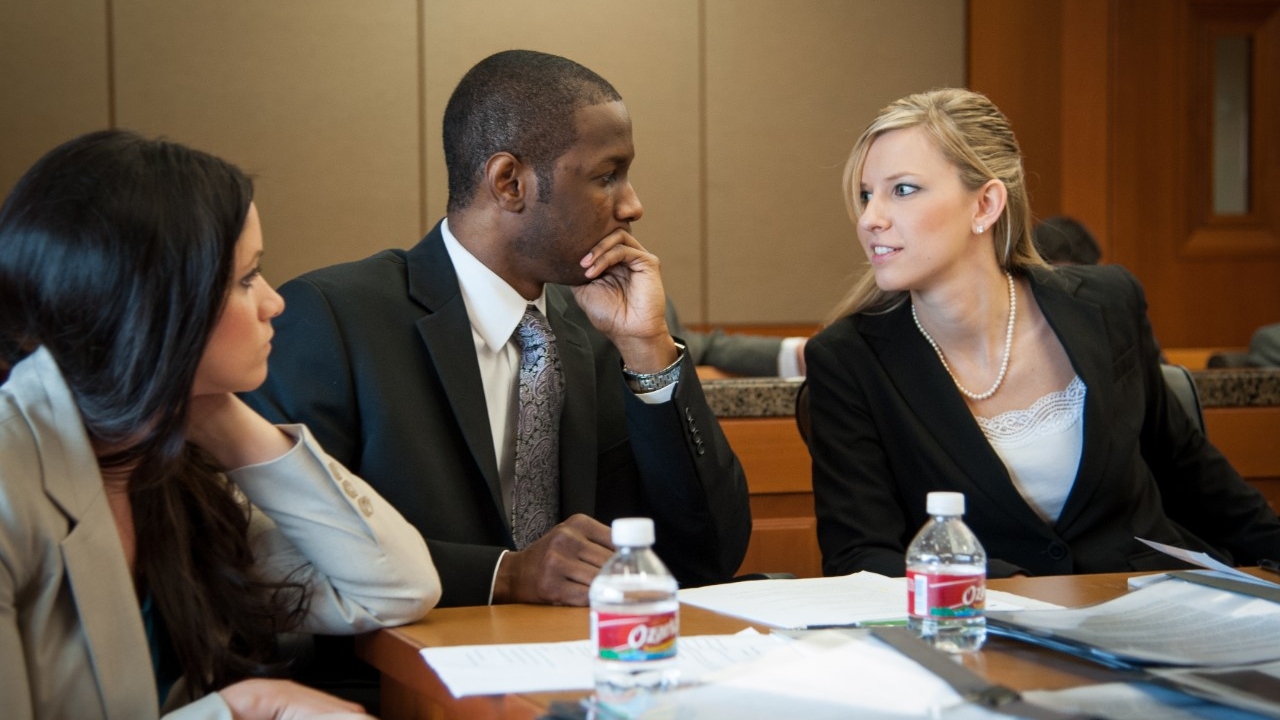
[440,218,547,352]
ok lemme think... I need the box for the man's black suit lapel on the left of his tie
[406,224,507,518]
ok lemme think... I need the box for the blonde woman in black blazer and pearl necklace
[806,88,1280,577]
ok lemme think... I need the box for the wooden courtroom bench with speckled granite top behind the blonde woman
[703,370,1280,578]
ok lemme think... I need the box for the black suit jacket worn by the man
[247,225,751,605]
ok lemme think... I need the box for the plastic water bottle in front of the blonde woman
[906,492,987,652]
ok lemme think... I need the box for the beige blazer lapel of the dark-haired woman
[14,348,157,720]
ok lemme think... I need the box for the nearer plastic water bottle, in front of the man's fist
[589,518,680,716]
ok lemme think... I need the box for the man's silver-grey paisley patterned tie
[511,305,564,550]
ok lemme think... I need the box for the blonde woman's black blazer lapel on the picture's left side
[863,304,1039,523]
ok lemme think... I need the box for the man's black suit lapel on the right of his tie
[547,286,596,519]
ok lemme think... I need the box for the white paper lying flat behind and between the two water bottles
[678,571,1060,629]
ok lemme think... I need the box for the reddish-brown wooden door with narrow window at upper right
[1110,0,1280,347]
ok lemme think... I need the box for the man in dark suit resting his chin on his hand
[250,51,751,605]
